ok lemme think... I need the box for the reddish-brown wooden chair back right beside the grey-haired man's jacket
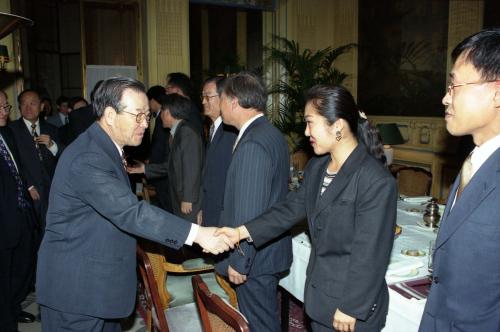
[136,246,169,332]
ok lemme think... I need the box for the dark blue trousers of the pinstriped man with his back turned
[236,274,281,332]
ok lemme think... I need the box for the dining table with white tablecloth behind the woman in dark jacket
[279,196,444,332]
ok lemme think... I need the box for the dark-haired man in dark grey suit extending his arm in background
[128,94,204,223]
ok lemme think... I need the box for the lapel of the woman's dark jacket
[312,143,366,219]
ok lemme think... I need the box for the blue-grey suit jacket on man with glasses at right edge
[420,149,500,332]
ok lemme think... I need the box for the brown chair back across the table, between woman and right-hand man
[396,167,432,196]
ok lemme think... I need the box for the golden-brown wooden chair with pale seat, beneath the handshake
[141,242,238,310]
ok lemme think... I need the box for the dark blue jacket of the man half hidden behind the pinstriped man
[201,123,238,226]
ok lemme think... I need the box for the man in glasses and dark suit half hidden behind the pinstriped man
[198,76,238,226]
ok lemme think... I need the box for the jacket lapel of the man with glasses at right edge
[436,149,500,248]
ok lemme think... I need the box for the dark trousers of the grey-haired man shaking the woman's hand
[40,305,121,332]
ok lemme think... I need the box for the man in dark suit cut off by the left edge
[0,91,36,332]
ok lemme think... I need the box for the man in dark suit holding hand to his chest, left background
[10,90,64,230]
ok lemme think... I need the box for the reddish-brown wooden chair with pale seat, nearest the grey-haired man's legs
[136,246,201,332]
